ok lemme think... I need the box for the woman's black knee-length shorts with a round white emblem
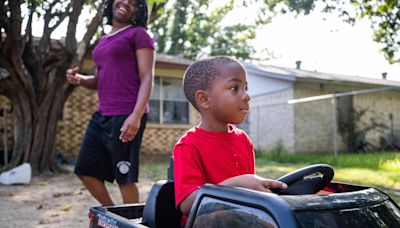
[75,112,147,184]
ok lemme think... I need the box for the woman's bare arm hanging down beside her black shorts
[119,48,155,142]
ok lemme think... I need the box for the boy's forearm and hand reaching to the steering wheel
[219,174,287,192]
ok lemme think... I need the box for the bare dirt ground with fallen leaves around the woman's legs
[0,166,154,228]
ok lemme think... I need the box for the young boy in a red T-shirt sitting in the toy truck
[173,56,287,224]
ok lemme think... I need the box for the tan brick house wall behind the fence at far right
[294,82,400,152]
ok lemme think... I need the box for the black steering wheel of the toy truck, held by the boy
[270,164,334,195]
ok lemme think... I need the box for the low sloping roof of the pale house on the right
[243,63,400,87]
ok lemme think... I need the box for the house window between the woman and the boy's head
[149,76,189,124]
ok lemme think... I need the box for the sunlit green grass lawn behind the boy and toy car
[140,152,400,204]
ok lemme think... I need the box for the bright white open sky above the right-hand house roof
[248,9,400,81]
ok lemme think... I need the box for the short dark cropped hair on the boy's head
[183,56,240,109]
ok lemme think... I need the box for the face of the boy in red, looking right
[208,62,250,124]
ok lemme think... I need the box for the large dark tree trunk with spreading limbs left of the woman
[0,0,106,174]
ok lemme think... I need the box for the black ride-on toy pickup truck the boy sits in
[89,164,400,228]
